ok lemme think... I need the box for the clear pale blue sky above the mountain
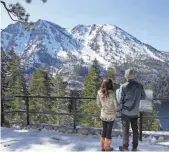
[1,0,169,51]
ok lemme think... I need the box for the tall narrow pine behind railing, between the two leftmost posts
[8,49,27,121]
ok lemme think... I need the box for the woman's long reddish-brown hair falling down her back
[101,79,113,98]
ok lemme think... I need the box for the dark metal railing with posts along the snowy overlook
[1,96,169,141]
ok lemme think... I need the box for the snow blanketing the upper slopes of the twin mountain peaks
[1,20,168,73]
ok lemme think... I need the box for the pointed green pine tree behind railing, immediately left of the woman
[80,59,101,127]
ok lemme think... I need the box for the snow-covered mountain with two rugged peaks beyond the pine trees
[1,20,169,85]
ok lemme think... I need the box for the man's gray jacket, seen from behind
[117,80,146,116]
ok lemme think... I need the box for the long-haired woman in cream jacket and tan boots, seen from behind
[97,79,116,151]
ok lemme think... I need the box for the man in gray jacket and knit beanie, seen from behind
[117,69,146,151]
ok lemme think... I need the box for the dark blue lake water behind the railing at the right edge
[155,102,169,131]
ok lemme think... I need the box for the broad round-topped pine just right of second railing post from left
[30,69,52,123]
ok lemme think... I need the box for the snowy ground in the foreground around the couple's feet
[0,128,169,152]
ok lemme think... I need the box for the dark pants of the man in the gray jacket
[122,115,138,148]
